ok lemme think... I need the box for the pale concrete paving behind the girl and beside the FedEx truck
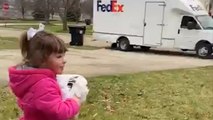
[0,29,213,84]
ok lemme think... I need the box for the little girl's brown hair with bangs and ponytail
[20,31,67,67]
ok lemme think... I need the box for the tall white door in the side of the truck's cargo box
[143,1,166,46]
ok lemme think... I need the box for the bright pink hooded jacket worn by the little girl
[9,67,79,120]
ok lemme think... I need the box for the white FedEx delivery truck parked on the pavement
[93,0,213,58]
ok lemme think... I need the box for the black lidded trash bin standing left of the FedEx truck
[68,25,86,46]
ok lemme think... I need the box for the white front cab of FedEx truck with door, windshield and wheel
[175,15,213,58]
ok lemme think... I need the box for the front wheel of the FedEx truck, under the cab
[196,43,212,59]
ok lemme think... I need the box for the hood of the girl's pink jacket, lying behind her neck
[9,67,55,98]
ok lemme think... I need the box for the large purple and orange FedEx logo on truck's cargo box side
[97,0,124,12]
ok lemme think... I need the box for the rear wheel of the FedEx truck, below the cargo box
[118,38,132,51]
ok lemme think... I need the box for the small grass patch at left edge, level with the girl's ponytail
[0,36,19,50]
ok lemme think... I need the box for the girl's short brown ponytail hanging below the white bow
[20,32,30,61]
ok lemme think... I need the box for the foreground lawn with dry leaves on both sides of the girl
[0,67,213,120]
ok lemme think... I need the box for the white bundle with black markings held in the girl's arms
[56,74,89,103]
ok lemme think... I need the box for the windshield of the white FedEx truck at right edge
[196,15,213,30]
